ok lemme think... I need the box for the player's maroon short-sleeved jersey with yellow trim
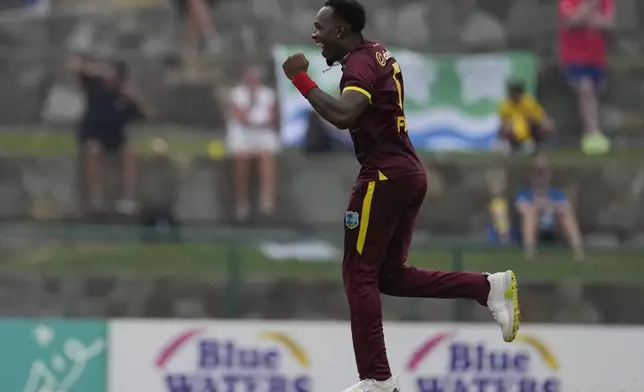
[340,41,425,181]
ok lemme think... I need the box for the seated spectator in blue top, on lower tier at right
[516,155,584,259]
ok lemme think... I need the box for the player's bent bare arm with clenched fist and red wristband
[282,53,369,129]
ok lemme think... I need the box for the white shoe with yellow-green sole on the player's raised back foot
[487,270,521,342]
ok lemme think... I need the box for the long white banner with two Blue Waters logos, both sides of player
[108,320,644,392]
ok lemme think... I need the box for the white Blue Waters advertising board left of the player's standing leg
[109,321,355,392]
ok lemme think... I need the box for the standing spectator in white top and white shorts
[227,66,279,221]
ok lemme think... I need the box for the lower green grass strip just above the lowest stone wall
[0,240,644,283]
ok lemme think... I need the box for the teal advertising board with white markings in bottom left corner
[0,319,107,392]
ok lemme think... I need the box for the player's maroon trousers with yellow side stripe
[342,175,489,381]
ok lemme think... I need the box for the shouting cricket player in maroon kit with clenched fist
[282,0,520,392]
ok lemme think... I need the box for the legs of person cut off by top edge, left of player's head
[175,0,221,56]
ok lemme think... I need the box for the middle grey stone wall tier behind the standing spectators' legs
[0,152,644,236]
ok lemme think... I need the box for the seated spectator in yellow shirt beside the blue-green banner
[499,81,553,152]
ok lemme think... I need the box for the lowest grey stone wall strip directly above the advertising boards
[0,272,644,324]
